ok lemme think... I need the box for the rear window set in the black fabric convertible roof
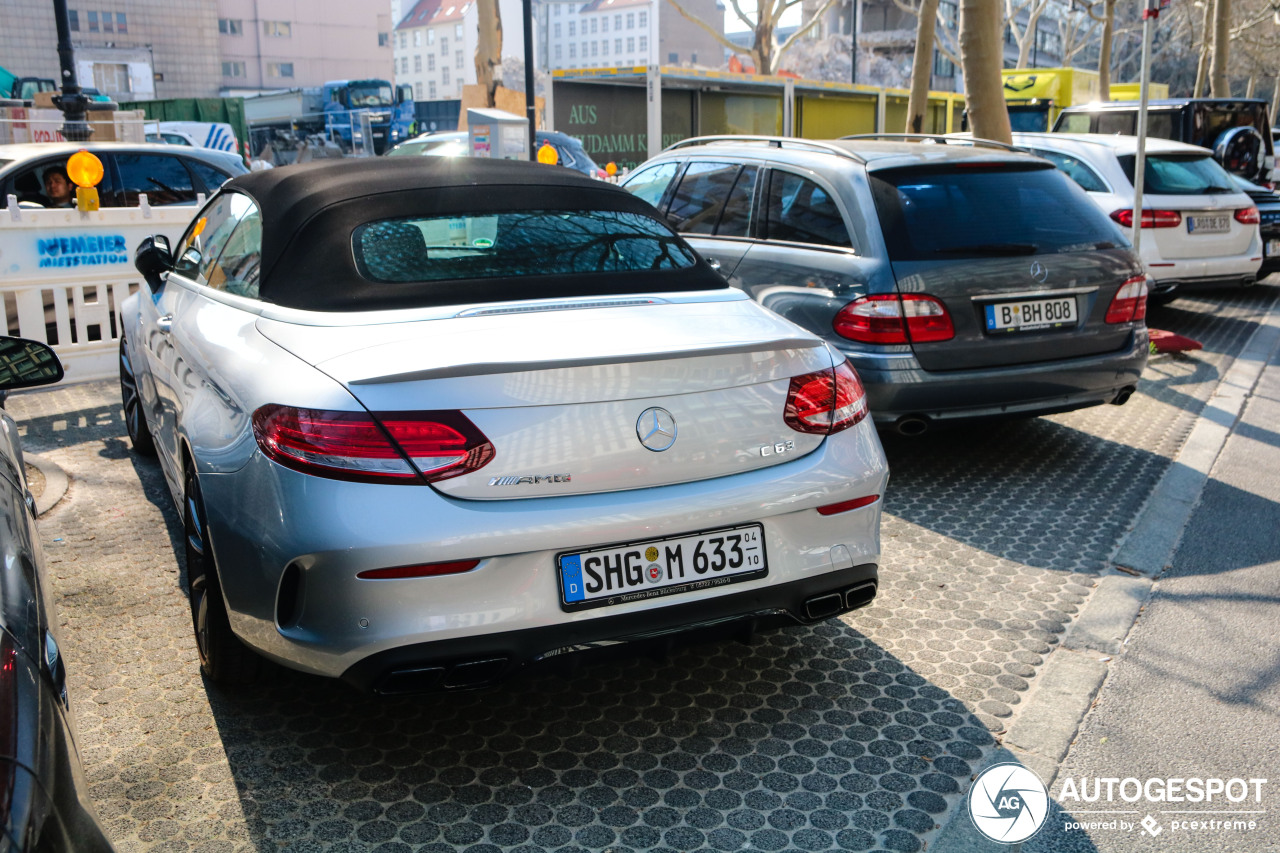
[352,210,698,283]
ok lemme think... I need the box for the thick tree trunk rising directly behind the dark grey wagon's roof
[960,0,1014,143]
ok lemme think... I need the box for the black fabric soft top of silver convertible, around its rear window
[223,156,726,311]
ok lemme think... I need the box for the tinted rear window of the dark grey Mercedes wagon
[872,163,1129,261]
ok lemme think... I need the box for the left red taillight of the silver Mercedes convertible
[253,405,494,484]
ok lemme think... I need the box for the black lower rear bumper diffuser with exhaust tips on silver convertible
[342,564,877,694]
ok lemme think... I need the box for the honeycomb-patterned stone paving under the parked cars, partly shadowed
[8,286,1280,853]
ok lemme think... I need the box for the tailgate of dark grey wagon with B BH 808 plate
[873,159,1142,370]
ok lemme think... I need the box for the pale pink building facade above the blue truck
[216,0,393,92]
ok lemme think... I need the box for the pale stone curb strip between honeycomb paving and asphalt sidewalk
[931,304,1280,853]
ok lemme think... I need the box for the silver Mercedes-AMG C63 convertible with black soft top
[120,158,888,693]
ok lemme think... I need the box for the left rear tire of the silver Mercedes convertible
[182,459,262,688]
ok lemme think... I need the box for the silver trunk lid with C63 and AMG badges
[259,293,832,500]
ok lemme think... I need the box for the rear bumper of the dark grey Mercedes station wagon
[846,327,1148,425]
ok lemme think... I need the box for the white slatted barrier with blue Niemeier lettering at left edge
[0,196,196,383]
